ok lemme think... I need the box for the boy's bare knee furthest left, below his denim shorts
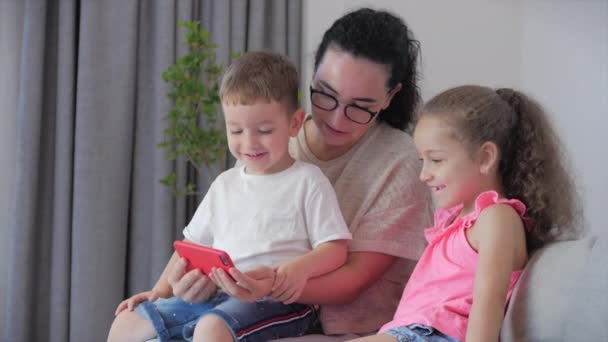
[108,311,156,342]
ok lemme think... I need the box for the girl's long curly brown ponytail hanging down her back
[496,88,580,250]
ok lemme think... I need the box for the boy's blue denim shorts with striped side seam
[135,292,318,342]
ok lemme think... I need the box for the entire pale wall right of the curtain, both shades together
[302,0,608,233]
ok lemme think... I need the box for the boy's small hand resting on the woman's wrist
[270,262,308,304]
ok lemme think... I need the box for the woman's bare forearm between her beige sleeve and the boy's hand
[298,252,397,305]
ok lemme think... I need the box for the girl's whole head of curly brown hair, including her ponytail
[419,86,582,251]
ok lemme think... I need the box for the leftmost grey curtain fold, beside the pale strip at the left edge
[3,1,57,341]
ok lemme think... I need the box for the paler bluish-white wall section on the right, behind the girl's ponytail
[521,0,608,234]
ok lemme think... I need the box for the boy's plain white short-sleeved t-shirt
[183,161,352,271]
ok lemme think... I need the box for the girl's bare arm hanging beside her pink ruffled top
[466,204,527,341]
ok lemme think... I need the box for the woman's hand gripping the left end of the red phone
[167,258,217,303]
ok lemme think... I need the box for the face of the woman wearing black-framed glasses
[311,48,395,149]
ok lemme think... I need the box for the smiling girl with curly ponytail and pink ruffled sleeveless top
[358,86,576,342]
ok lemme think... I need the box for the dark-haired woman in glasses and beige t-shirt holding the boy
[214,8,431,336]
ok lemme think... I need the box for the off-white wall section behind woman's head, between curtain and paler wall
[302,0,522,104]
